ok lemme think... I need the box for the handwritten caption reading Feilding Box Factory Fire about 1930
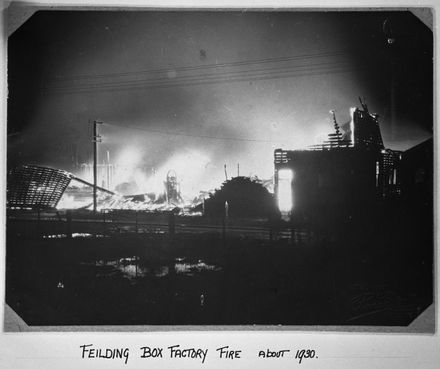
[79,343,318,364]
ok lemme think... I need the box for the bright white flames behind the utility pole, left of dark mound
[67,147,213,210]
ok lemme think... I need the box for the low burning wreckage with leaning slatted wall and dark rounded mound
[7,161,275,216]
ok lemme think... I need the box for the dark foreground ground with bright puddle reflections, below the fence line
[6,203,433,326]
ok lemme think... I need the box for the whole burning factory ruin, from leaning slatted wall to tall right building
[7,100,410,219]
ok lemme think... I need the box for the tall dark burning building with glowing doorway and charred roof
[274,101,401,223]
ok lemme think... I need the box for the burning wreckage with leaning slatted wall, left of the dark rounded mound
[7,165,208,214]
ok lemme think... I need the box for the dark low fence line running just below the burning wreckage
[7,211,312,243]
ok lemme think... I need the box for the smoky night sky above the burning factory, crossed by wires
[8,11,433,193]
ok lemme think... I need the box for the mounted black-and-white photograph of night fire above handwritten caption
[5,8,436,333]
